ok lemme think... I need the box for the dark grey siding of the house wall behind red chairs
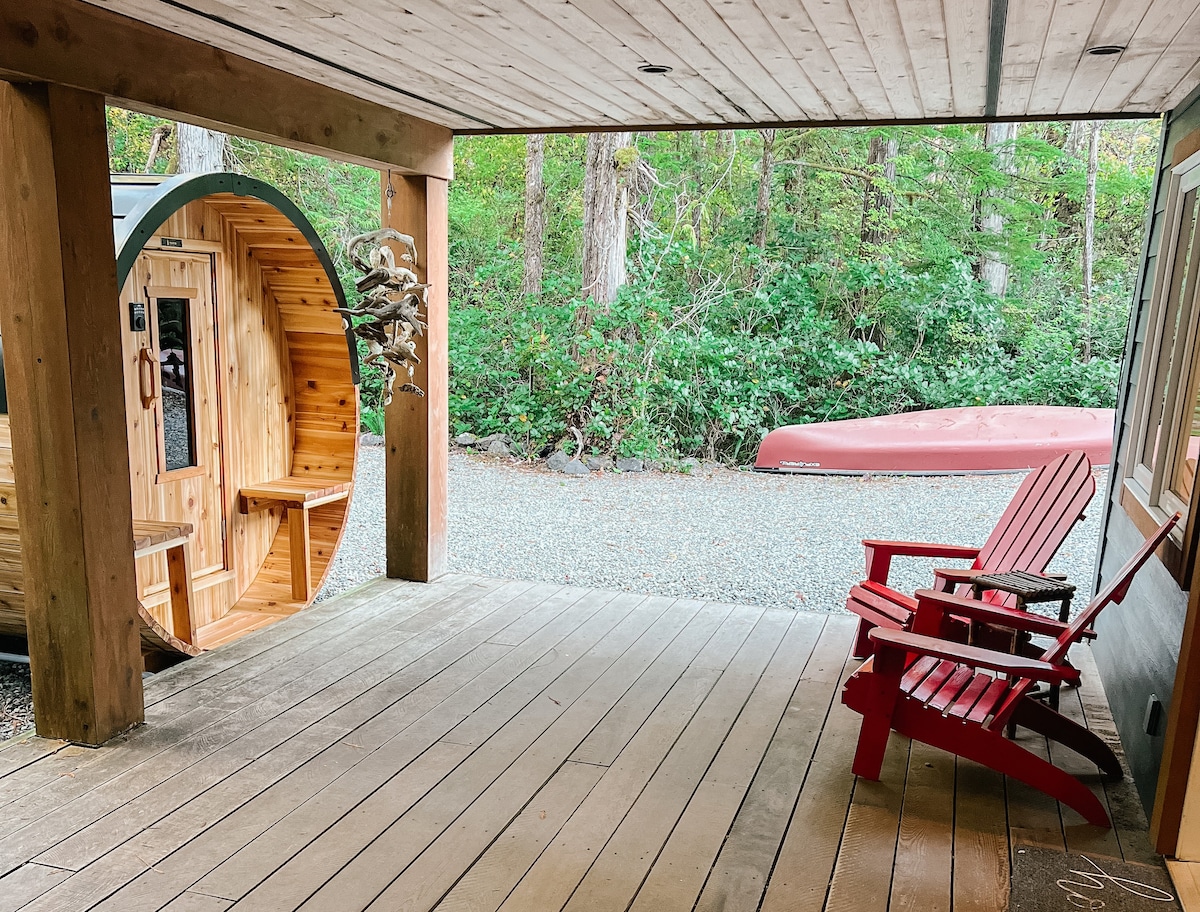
[1093,92,1200,814]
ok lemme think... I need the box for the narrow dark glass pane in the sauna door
[158,298,196,472]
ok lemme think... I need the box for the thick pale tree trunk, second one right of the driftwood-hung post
[578,126,632,314]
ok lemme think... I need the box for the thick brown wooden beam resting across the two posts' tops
[0,0,454,179]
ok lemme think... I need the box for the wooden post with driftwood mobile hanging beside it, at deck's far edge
[382,172,450,581]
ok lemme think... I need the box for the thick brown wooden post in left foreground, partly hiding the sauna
[0,82,143,744]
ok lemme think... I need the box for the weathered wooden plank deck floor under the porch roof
[0,576,1152,912]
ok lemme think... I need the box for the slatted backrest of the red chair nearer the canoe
[972,450,1096,604]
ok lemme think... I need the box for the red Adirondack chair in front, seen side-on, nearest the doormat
[841,514,1180,827]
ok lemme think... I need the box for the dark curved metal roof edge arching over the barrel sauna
[116,172,361,386]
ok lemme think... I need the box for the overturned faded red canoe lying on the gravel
[754,406,1115,475]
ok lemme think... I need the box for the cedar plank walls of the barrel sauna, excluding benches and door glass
[0,175,359,661]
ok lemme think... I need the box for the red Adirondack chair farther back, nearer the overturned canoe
[846,450,1096,658]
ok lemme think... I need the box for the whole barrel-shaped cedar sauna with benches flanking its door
[0,174,359,667]
